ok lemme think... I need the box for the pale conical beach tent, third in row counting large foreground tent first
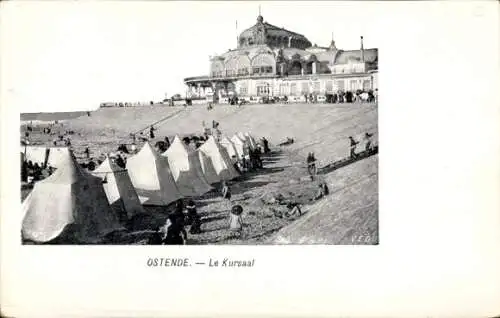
[127,142,182,206]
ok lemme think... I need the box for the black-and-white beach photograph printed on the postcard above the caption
[18,2,383,245]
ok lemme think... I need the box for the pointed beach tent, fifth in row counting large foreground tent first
[199,136,239,180]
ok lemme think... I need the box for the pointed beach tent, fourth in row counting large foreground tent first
[162,136,212,197]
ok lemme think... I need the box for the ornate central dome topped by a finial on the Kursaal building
[238,15,311,49]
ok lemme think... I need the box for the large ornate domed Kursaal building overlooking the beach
[184,15,378,103]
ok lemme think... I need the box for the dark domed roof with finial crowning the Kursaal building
[239,15,311,48]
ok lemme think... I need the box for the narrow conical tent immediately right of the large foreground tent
[92,157,145,220]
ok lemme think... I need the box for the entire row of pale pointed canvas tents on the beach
[21,133,257,243]
